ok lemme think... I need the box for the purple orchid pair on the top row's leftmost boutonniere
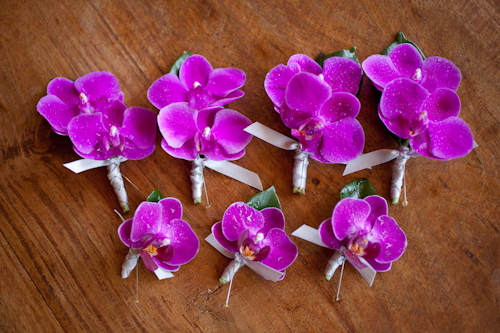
[37,72,156,160]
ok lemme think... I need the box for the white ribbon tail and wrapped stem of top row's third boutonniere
[244,122,309,194]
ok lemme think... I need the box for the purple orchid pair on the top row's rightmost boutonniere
[363,43,474,160]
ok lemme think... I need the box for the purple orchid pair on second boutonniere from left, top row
[148,55,252,161]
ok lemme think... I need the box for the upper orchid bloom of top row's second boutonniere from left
[148,54,246,110]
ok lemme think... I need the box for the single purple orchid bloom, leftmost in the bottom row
[118,198,200,272]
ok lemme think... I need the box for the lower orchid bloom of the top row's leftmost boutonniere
[67,96,156,160]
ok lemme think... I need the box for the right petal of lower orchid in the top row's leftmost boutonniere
[120,106,156,149]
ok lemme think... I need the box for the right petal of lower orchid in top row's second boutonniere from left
[211,109,252,154]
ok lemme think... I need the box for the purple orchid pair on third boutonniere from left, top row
[264,54,365,163]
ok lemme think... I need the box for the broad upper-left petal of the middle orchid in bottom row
[222,202,264,241]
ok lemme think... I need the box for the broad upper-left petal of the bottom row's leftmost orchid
[130,201,162,243]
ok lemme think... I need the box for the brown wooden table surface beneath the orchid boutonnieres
[0,0,500,332]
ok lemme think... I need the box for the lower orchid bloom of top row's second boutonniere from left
[158,103,252,161]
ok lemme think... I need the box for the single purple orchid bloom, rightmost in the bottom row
[319,195,407,272]
